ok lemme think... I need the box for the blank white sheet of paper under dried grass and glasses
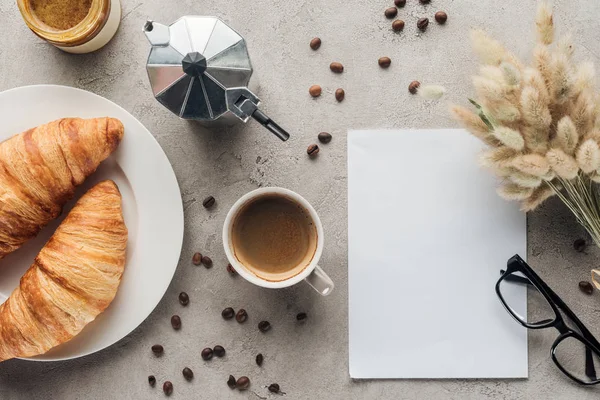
[348,130,527,378]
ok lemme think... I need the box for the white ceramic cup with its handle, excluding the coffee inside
[223,187,335,296]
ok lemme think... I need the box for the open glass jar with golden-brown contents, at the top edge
[17,0,121,54]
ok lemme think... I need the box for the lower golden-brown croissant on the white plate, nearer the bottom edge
[0,181,127,361]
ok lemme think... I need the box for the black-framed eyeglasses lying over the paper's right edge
[496,255,600,385]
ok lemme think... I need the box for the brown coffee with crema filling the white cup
[231,194,317,282]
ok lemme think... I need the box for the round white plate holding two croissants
[0,85,183,361]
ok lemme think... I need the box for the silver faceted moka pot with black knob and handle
[144,16,290,141]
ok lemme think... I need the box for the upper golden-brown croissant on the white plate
[0,118,123,259]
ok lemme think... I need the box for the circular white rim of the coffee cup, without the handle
[223,187,324,289]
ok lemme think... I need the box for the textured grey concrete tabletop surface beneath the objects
[0,0,600,400]
